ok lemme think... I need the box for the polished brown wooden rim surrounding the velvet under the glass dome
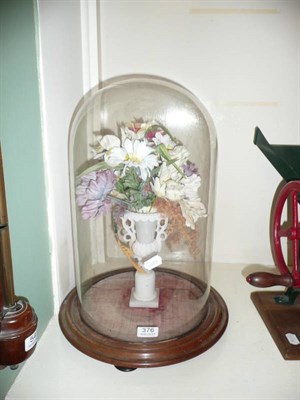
[59,270,228,370]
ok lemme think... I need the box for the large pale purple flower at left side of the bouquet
[76,170,116,219]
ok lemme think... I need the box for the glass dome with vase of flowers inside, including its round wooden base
[60,76,228,370]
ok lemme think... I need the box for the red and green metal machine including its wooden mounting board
[246,128,300,360]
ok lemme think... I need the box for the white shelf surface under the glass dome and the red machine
[6,264,300,400]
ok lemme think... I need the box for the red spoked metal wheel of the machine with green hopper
[272,181,300,288]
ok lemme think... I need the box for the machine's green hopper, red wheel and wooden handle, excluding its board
[247,128,300,302]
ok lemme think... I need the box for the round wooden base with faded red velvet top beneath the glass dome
[59,268,228,369]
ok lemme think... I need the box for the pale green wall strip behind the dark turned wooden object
[0,0,53,400]
